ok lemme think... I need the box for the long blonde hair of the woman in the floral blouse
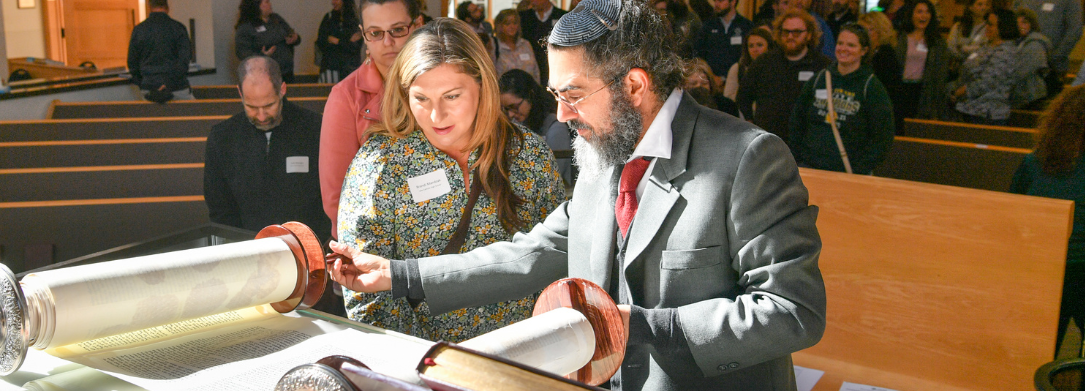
[366,17,525,232]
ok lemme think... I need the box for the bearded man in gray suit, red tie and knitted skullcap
[330,0,826,390]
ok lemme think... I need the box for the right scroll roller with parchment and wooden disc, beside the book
[276,278,626,391]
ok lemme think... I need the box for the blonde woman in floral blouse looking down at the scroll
[332,18,565,342]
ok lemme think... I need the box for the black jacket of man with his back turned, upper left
[128,12,192,91]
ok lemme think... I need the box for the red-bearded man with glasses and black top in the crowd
[736,9,830,145]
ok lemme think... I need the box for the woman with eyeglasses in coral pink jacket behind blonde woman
[319,0,422,238]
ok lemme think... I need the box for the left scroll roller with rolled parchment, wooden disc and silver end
[0,222,327,376]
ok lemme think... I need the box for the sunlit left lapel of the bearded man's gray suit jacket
[588,167,621,287]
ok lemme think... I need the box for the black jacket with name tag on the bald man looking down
[204,100,331,240]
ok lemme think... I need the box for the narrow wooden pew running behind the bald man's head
[46,98,328,119]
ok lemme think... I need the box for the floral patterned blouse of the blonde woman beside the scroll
[337,129,565,342]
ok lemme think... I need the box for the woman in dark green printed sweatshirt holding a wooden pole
[789,23,893,175]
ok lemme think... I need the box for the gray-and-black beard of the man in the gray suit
[569,91,643,179]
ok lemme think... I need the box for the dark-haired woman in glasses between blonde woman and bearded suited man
[497,70,575,187]
